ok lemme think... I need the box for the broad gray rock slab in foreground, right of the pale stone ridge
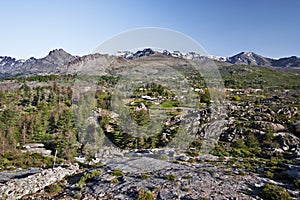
[64,157,261,200]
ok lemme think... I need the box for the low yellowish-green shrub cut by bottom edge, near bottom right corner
[261,183,292,200]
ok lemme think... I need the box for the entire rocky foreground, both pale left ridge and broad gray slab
[0,157,299,200]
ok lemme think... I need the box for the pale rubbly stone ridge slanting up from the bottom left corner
[0,165,79,199]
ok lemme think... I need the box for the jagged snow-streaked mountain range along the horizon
[0,48,300,78]
